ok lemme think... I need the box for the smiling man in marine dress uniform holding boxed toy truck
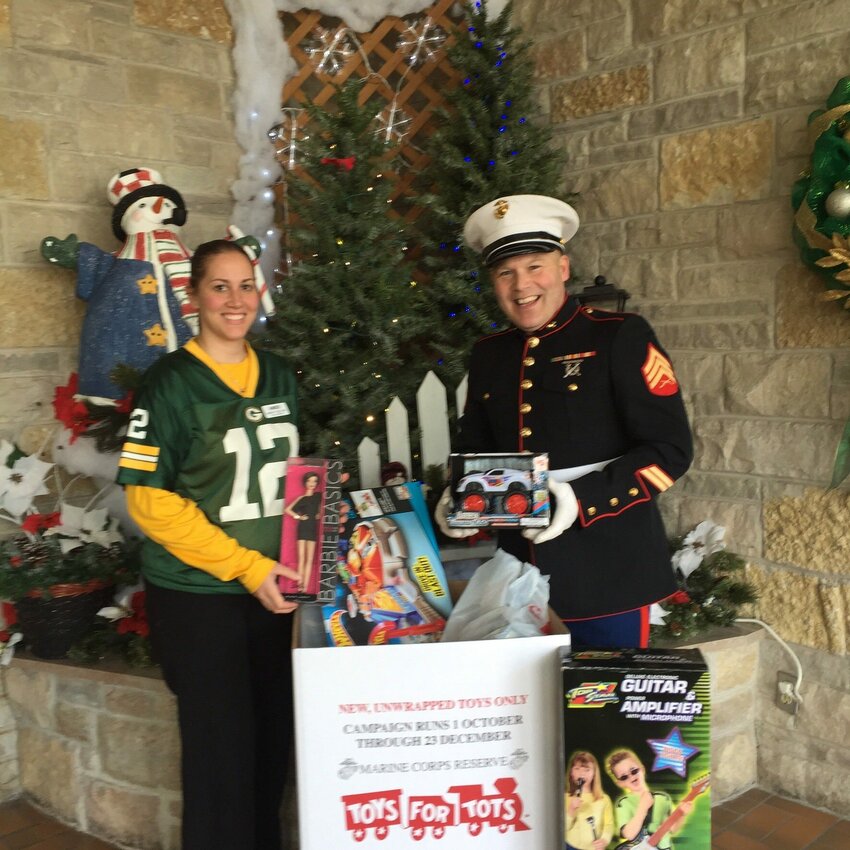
[438,190,693,647]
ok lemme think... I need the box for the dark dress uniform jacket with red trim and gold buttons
[458,298,693,619]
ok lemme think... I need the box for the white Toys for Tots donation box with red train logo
[293,606,569,850]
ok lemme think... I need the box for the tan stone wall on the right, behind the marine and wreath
[514,0,850,811]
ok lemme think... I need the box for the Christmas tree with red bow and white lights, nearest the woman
[266,79,439,470]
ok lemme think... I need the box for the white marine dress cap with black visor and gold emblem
[463,195,578,266]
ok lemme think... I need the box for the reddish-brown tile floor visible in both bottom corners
[0,789,850,850]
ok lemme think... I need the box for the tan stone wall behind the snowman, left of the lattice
[0,0,239,449]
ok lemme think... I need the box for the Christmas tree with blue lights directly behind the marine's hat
[419,0,563,378]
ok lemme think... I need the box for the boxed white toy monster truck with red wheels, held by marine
[446,452,549,528]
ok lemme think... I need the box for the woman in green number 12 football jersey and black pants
[118,240,298,850]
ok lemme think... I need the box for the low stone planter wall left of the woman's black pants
[3,659,181,850]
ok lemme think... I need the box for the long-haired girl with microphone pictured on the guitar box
[564,750,614,850]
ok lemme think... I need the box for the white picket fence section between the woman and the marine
[357,372,467,487]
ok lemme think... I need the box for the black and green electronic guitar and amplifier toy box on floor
[562,649,711,850]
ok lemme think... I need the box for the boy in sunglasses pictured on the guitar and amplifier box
[608,750,694,850]
